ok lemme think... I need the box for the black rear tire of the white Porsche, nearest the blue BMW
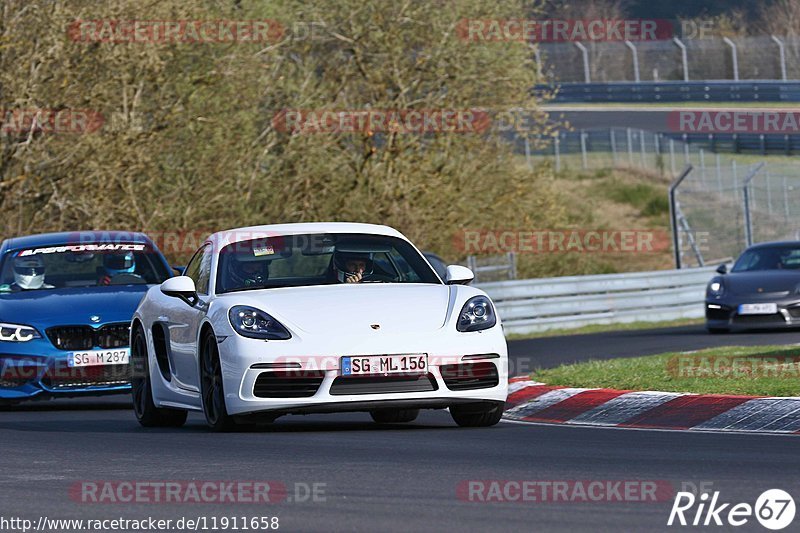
[131,328,188,428]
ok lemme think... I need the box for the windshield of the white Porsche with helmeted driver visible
[216,233,441,294]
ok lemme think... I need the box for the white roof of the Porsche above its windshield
[208,222,408,248]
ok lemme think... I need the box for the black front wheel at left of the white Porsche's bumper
[200,330,236,431]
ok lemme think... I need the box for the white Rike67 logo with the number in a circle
[667,489,795,531]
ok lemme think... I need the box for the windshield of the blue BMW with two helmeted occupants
[0,242,170,293]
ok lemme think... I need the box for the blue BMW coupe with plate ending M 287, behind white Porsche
[0,231,173,405]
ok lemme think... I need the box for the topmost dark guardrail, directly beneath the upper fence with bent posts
[534,80,800,103]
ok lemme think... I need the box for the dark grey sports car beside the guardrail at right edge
[706,242,800,333]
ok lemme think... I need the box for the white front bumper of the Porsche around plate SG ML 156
[219,325,508,416]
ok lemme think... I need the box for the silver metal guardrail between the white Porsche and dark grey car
[479,267,715,334]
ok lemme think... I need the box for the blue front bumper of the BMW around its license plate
[0,337,131,402]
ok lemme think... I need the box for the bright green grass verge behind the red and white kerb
[532,346,800,396]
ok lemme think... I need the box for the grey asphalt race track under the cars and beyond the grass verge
[0,328,800,531]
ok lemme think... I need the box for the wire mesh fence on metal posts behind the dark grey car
[527,128,800,267]
